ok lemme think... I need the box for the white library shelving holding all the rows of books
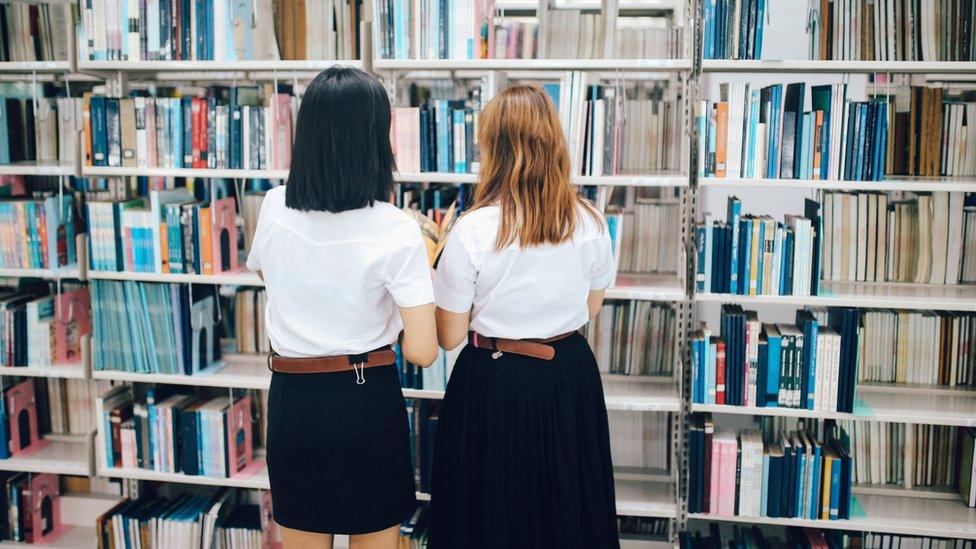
[0,0,976,547]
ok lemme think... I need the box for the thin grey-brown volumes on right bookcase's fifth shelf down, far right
[842,420,962,488]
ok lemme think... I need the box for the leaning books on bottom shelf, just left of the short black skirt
[95,488,278,549]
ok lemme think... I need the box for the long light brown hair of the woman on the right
[473,85,603,250]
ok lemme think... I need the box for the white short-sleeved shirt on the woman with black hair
[247,186,434,357]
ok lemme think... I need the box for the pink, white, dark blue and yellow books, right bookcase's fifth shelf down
[688,414,853,520]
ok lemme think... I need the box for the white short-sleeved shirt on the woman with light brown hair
[434,205,616,339]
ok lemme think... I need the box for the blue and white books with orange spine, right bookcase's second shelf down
[696,82,891,181]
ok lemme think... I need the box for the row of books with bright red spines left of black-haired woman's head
[82,89,298,170]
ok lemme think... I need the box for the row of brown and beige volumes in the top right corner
[808,0,976,61]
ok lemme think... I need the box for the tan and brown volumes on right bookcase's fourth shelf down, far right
[857,310,976,386]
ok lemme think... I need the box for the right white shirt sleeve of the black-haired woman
[384,226,434,307]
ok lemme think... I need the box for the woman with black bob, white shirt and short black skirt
[247,68,437,549]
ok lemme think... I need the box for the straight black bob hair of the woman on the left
[285,63,396,213]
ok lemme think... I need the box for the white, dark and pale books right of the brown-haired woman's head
[578,83,678,175]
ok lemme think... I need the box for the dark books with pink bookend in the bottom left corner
[0,471,61,543]
